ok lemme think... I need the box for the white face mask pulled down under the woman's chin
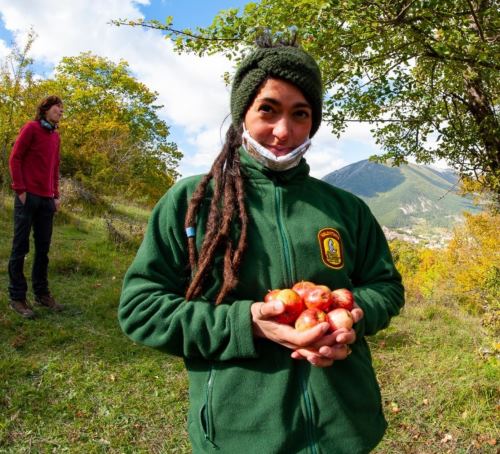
[241,125,311,172]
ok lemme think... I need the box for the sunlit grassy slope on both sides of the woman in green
[0,195,500,454]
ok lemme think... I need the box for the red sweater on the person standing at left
[9,121,61,198]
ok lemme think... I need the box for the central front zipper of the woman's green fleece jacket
[274,181,318,454]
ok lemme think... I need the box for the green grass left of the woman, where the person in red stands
[0,193,189,453]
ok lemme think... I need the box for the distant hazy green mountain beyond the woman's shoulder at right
[322,159,480,245]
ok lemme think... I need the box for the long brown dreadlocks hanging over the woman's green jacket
[184,125,248,304]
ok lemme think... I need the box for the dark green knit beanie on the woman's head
[231,46,323,137]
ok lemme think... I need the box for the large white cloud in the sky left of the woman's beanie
[0,0,231,133]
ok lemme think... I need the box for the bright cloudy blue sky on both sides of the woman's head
[0,0,378,177]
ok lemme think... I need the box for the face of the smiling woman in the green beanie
[244,79,312,157]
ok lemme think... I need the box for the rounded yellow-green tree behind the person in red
[45,53,182,202]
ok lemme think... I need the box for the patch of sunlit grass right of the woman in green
[370,301,500,454]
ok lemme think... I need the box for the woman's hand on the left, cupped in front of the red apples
[250,302,329,350]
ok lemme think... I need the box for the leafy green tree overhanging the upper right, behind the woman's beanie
[115,0,500,200]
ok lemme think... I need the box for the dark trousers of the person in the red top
[9,193,55,300]
